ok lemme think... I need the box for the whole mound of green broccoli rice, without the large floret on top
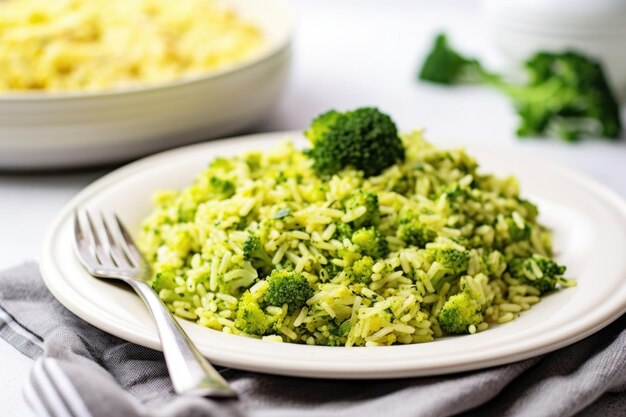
[139,131,573,346]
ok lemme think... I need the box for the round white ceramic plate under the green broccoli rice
[41,133,626,378]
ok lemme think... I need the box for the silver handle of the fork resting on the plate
[126,279,237,397]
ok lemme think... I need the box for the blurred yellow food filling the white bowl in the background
[0,0,264,94]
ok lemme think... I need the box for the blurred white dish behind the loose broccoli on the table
[483,0,626,97]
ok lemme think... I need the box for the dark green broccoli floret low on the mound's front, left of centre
[264,269,313,314]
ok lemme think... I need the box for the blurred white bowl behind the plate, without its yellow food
[0,0,294,170]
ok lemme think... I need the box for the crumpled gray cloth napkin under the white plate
[0,263,626,417]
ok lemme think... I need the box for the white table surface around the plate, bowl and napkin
[0,0,626,417]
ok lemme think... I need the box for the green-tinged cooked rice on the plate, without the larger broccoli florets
[140,131,568,346]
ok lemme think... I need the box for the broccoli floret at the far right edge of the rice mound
[509,254,565,294]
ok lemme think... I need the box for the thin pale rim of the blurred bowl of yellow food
[0,0,295,104]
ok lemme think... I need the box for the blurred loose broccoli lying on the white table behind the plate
[419,35,622,141]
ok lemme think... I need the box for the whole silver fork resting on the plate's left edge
[74,210,237,397]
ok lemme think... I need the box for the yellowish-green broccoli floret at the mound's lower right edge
[439,292,483,334]
